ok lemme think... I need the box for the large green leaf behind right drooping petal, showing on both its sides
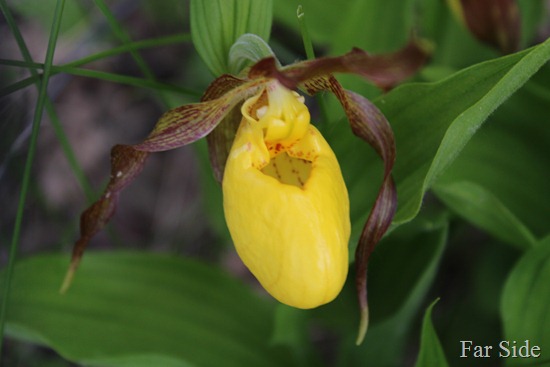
[322,40,550,246]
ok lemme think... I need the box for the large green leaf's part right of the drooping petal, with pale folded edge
[382,39,550,227]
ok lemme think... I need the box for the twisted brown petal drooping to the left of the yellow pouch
[61,75,263,292]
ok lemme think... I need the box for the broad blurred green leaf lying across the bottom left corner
[0,252,289,366]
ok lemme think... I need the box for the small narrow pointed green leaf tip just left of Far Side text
[415,299,449,367]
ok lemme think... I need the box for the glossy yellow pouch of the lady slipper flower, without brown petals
[223,81,350,308]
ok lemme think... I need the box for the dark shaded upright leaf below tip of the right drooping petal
[338,215,448,367]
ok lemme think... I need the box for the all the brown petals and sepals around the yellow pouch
[62,39,418,308]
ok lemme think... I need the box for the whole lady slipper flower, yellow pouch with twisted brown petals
[61,40,427,343]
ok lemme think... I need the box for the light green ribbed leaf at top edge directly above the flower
[190,0,273,76]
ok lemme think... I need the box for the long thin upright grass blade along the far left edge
[0,0,65,356]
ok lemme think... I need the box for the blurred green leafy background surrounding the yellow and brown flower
[0,0,550,366]
